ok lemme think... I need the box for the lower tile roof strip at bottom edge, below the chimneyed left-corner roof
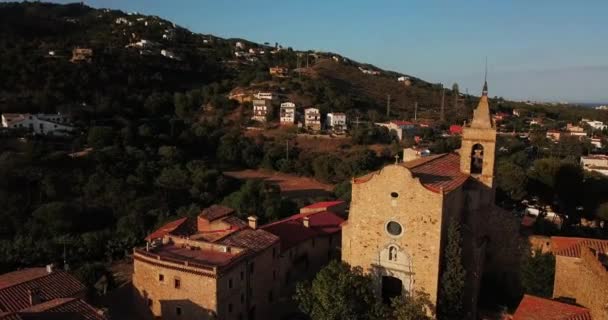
[19,298,108,320]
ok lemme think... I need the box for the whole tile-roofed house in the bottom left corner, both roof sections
[0,265,107,320]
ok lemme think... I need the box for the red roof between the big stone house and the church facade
[262,211,344,251]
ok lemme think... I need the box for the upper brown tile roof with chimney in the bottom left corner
[0,268,86,312]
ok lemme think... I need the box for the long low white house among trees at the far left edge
[2,113,74,136]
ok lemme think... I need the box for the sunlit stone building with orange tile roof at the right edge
[551,237,608,320]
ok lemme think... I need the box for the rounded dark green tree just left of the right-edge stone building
[521,250,555,298]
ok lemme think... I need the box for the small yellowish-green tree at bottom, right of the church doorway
[391,291,434,320]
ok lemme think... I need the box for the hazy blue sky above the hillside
[47,0,608,102]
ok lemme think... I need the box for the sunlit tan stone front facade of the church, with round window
[342,165,443,304]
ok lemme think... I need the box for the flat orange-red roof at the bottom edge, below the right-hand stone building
[513,295,591,320]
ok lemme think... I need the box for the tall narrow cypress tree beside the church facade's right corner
[438,220,466,319]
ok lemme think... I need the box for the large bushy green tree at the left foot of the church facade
[294,260,385,320]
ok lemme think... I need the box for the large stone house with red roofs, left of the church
[133,202,344,320]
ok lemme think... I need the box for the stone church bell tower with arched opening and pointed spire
[460,81,496,189]
